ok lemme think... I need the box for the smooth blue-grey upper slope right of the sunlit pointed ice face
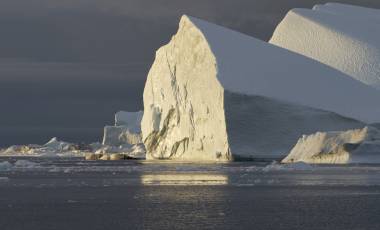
[189,14,380,123]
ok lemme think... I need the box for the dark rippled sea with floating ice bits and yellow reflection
[0,158,380,230]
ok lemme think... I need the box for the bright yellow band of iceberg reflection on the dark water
[141,173,228,185]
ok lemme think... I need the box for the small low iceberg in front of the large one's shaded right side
[282,127,380,164]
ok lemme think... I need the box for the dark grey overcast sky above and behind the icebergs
[0,0,380,147]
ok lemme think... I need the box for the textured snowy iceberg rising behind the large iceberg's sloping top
[269,3,380,89]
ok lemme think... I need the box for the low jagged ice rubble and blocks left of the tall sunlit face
[0,111,145,160]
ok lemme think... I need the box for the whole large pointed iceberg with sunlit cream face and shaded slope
[141,16,380,160]
